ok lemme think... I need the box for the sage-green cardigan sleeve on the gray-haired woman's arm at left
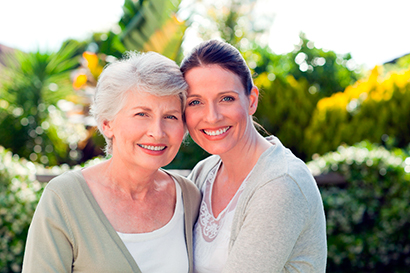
[22,187,74,273]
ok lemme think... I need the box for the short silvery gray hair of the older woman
[90,51,188,154]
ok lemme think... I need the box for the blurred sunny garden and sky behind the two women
[0,0,410,272]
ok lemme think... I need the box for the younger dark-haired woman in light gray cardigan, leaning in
[181,41,327,273]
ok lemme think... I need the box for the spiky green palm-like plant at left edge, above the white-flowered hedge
[0,43,85,164]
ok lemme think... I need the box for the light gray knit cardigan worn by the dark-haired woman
[188,136,327,273]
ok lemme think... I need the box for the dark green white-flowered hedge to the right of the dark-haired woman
[308,142,410,273]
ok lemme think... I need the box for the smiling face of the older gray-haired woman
[104,89,185,169]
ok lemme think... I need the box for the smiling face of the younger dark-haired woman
[185,65,258,155]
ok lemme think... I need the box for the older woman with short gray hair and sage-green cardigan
[23,52,200,273]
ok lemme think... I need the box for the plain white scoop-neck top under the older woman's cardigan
[117,180,189,273]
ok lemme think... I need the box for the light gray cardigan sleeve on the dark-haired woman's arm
[223,176,308,273]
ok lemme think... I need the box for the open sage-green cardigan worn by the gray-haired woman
[22,170,201,273]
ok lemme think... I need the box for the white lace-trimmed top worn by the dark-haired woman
[194,164,249,273]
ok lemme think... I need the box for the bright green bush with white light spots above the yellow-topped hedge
[244,33,360,97]
